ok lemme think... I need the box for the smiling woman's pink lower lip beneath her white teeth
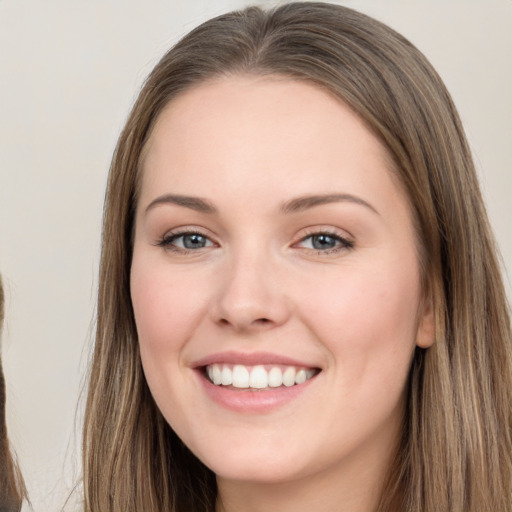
[197,371,318,414]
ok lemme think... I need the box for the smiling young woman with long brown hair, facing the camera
[83,3,512,512]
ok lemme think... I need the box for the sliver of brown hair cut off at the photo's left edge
[0,276,27,512]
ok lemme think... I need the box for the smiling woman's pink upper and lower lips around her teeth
[191,352,321,414]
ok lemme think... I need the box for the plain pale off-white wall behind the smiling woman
[0,0,512,512]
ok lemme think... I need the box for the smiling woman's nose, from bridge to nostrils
[211,251,291,332]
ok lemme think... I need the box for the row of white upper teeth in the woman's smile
[206,363,316,389]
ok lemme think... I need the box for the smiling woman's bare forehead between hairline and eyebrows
[137,75,408,216]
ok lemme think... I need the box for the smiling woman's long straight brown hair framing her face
[83,2,512,512]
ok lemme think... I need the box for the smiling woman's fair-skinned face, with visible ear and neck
[131,76,433,512]
